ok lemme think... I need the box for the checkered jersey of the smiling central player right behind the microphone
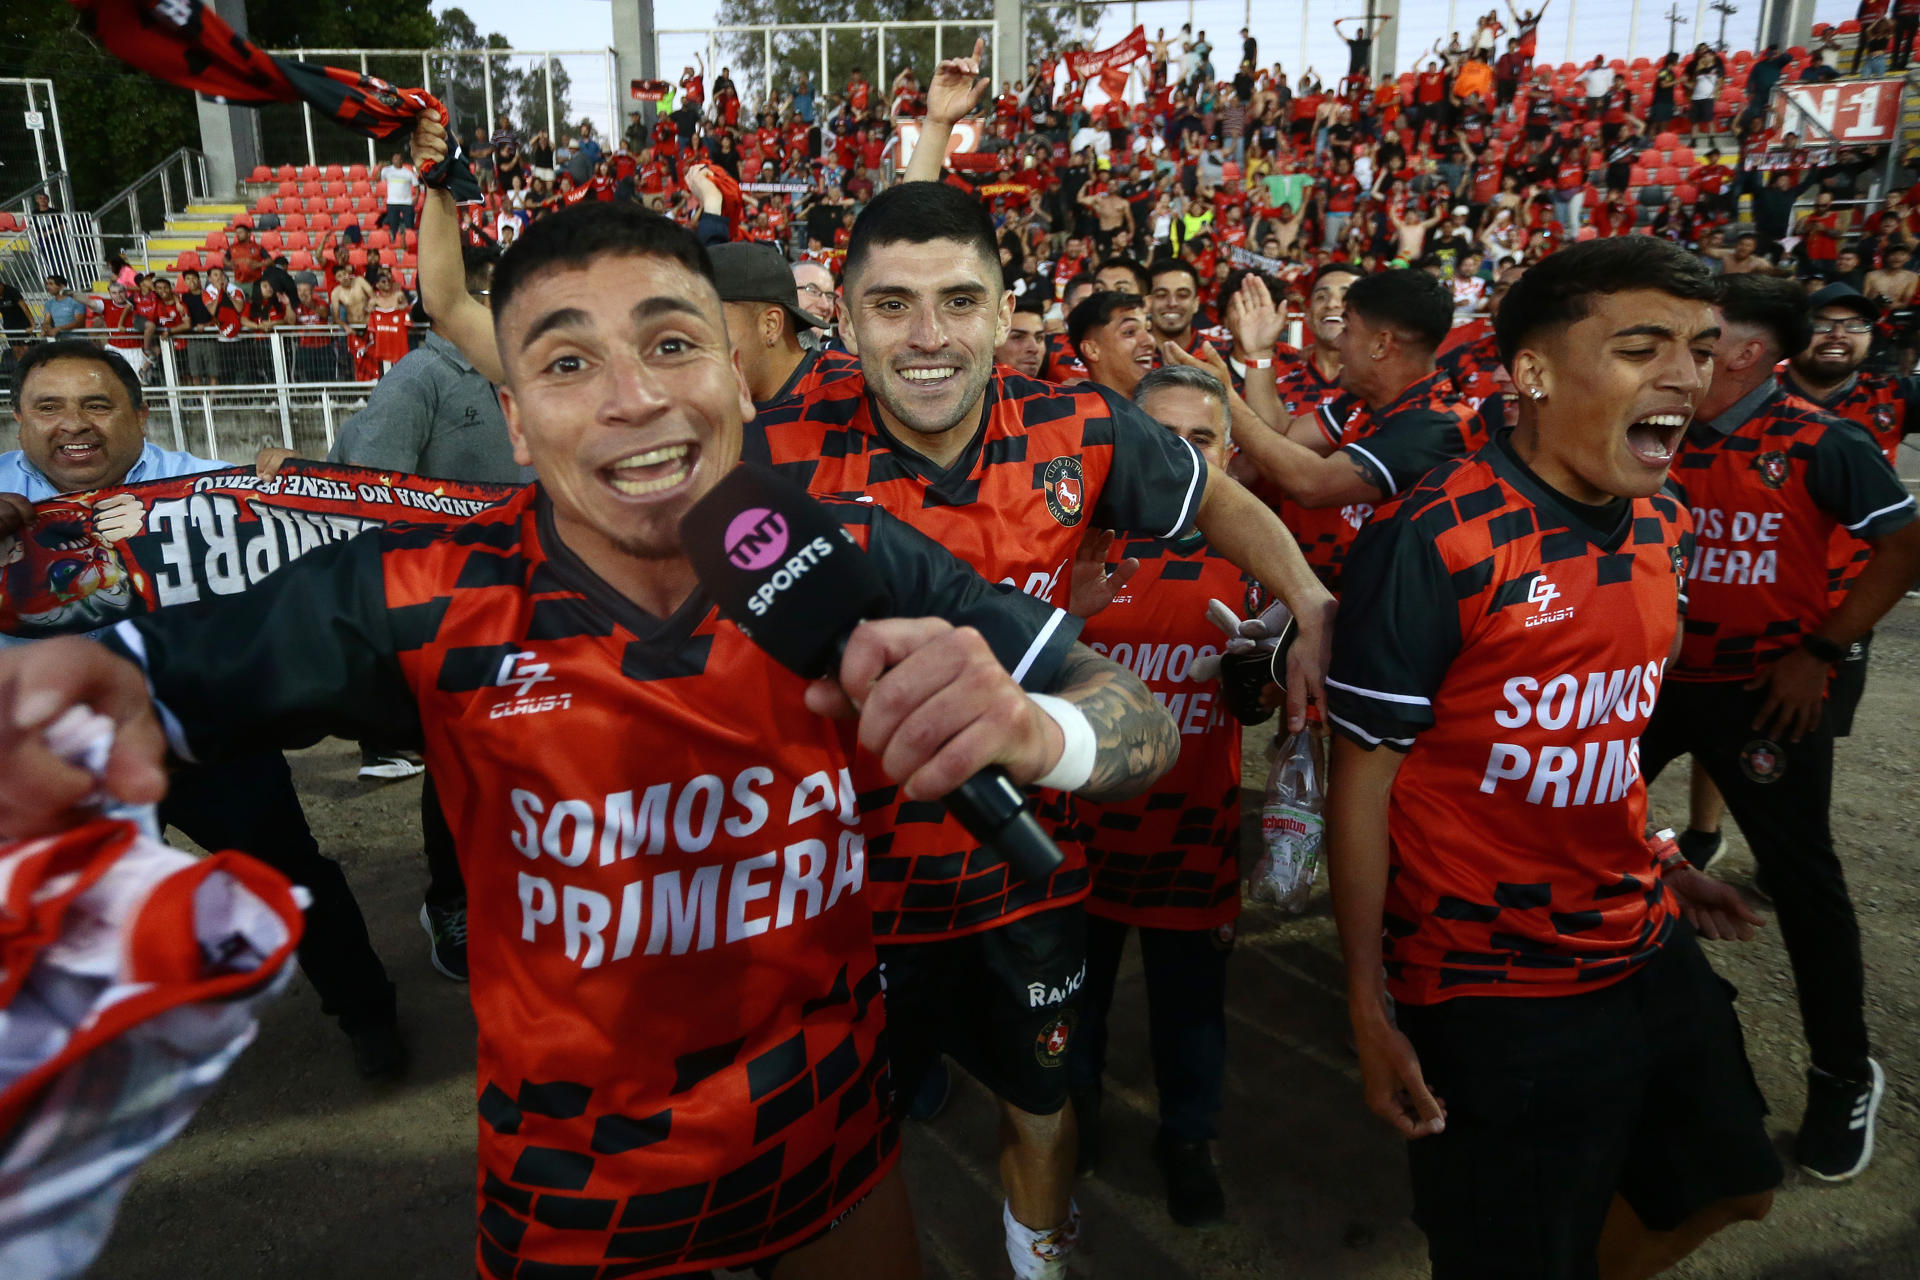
[743,367,1206,940]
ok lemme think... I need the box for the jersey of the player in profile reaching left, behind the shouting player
[1281,368,1486,595]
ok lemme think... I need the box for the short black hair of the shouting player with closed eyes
[1489,236,1720,367]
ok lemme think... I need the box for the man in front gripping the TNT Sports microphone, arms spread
[0,203,1177,1280]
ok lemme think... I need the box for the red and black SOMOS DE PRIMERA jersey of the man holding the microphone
[105,487,1071,1280]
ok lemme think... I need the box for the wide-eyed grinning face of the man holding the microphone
[497,253,753,560]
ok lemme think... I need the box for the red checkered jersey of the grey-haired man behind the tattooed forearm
[1079,535,1261,929]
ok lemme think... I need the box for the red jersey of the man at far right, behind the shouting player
[1672,382,1914,679]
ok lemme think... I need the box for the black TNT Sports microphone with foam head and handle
[680,462,1066,881]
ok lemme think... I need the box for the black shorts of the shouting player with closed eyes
[1398,921,1780,1280]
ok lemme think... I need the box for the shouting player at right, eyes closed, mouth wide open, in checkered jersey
[1327,236,1780,1280]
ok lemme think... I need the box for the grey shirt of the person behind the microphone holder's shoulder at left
[326,334,534,484]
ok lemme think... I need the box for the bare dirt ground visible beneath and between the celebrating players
[94,601,1920,1280]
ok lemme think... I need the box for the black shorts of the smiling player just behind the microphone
[879,902,1087,1115]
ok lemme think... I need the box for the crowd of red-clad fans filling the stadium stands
[0,4,1920,397]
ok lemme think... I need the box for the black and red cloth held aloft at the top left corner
[69,0,480,203]
